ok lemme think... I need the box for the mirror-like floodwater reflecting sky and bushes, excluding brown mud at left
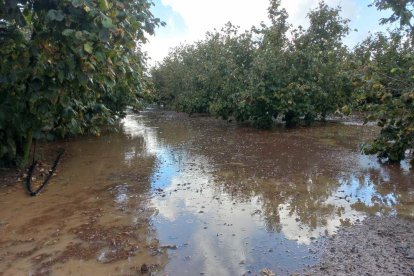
[124,111,414,275]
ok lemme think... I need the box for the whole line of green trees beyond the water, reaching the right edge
[150,0,414,164]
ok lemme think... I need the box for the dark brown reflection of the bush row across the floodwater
[147,111,413,236]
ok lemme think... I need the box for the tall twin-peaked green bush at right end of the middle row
[249,2,350,126]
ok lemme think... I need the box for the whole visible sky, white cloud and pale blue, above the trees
[144,0,388,64]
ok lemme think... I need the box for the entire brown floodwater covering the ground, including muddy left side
[0,110,414,275]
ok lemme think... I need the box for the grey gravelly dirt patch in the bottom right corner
[305,217,414,276]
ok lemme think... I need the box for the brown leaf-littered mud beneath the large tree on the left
[0,134,166,275]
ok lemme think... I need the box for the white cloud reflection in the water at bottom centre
[153,166,260,275]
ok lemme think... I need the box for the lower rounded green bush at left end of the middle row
[151,23,253,118]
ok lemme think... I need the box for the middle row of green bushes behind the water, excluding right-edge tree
[152,0,351,128]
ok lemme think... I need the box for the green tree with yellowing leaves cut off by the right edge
[355,0,414,163]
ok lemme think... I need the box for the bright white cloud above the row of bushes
[144,0,360,61]
